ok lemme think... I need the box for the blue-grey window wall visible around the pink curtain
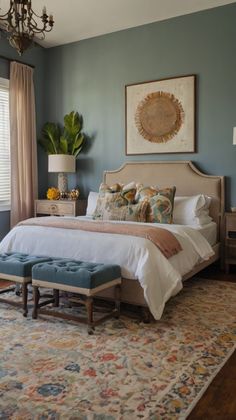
[0,39,47,240]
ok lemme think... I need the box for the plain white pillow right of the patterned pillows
[173,194,212,225]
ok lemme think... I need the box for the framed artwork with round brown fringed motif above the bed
[125,75,196,155]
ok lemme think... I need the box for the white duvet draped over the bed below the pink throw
[0,217,214,319]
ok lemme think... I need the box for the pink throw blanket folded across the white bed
[18,216,182,258]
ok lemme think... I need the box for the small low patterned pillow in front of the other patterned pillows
[102,201,148,223]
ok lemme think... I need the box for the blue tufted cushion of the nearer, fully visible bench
[32,259,121,295]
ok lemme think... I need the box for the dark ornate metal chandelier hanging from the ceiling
[0,0,54,55]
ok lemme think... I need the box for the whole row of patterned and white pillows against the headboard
[86,188,212,226]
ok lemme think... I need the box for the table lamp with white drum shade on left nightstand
[48,155,75,193]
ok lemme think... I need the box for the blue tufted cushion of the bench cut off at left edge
[0,252,50,283]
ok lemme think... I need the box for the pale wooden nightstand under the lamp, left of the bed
[34,200,87,217]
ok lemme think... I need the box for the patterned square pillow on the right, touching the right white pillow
[136,187,176,224]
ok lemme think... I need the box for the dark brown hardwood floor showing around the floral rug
[0,264,236,420]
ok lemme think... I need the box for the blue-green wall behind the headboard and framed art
[43,3,236,206]
